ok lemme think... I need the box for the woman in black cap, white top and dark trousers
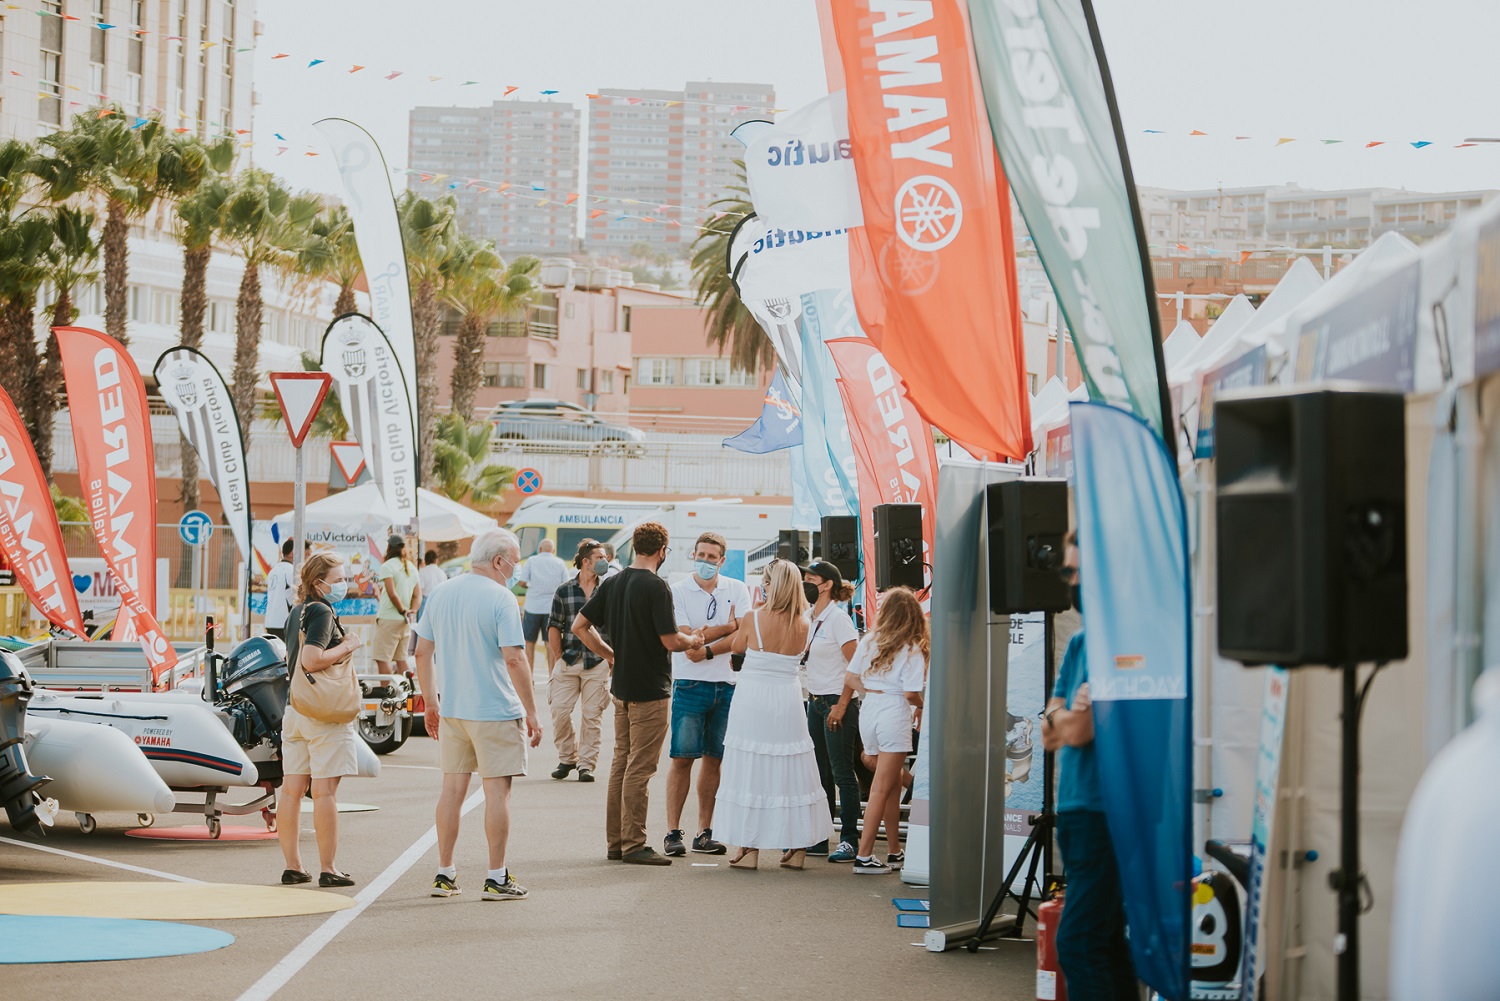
[803,560,864,861]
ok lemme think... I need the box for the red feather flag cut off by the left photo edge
[0,389,87,639]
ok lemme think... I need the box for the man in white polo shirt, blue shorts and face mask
[663,531,750,855]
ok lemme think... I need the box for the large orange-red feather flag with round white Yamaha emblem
[821,0,1032,461]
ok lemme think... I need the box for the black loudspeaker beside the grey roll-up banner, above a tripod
[986,477,1073,615]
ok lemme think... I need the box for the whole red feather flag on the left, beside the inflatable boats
[54,327,177,678]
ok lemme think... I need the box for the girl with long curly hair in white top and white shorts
[849,587,930,873]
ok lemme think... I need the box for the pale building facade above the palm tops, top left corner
[0,0,258,140]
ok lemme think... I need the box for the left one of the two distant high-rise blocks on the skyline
[407,101,579,257]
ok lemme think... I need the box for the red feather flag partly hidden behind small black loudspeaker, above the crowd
[827,338,938,603]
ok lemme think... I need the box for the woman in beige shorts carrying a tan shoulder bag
[276,552,360,887]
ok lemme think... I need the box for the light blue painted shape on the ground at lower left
[0,914,234,963]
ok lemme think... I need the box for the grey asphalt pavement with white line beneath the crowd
[0,672,1035,1001]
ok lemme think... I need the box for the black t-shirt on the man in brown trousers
[582,567,677,702]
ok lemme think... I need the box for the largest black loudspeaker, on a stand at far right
[1214,390,1407,668]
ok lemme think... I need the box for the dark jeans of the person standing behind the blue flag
[1058,810,1140,1001]
